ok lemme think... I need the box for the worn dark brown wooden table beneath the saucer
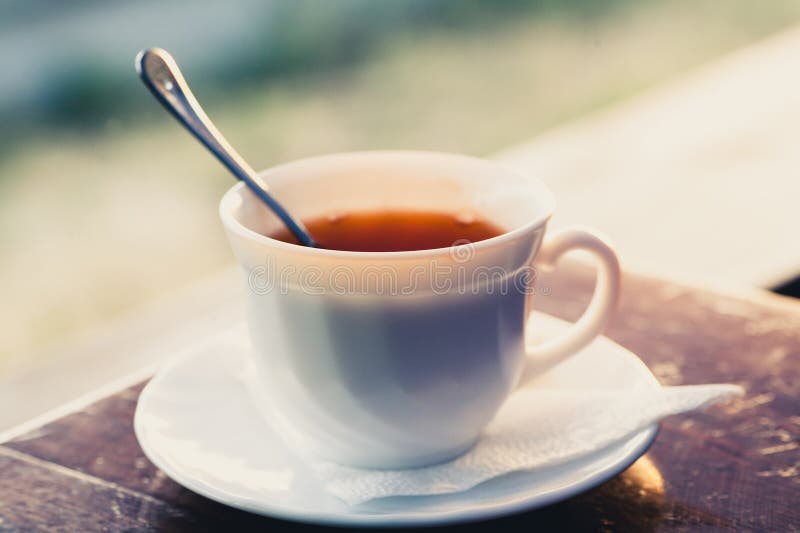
[0,269,800,532]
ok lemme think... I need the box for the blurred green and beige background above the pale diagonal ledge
[0,0,800,372]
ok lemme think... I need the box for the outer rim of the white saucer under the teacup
[133,313,660,528]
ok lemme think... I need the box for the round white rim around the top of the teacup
[219,150,555,259]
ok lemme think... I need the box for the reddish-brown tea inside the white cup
[270,211,504,252]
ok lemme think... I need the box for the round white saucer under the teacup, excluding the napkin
[134,313,658,526]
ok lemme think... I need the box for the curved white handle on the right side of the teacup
[519,227,621,385]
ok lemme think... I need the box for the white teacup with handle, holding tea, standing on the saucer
[220,152,620,468]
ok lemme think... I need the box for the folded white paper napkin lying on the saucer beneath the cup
[311,385,743,505]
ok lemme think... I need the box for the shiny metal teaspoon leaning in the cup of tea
[136,48,320,248]
